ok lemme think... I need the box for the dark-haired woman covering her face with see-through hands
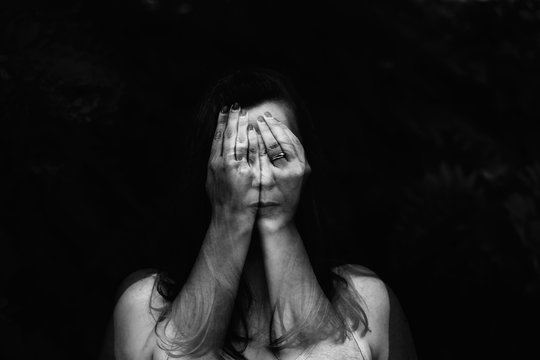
[106,70,416,360]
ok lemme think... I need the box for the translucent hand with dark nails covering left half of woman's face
[206,103,260,221]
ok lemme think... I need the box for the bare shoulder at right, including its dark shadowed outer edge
[334,264,416,360]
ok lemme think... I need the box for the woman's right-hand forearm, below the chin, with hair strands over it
[261,224,337,346]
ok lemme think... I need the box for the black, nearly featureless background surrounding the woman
[0,0,540,359]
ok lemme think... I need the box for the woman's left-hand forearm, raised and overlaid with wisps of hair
[167,215,253,354]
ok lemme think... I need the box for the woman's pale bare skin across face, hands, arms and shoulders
[108,102,415,360]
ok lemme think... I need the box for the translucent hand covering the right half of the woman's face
[257,112,311,229]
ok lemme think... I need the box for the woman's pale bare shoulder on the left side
[113,270,164,360]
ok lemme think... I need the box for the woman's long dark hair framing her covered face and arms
[150,69,368,359]
